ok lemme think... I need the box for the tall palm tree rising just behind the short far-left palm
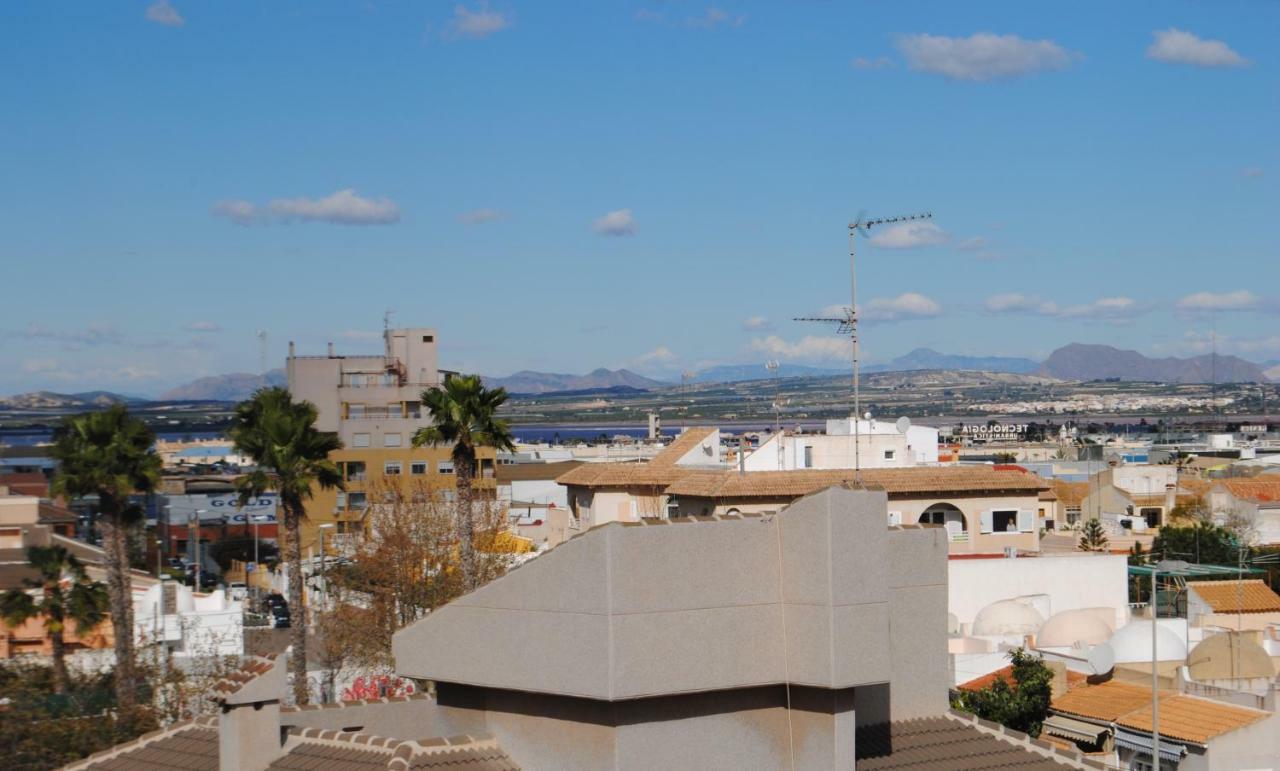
[51,405,160,710]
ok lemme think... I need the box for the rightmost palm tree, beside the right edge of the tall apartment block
[413,375,516,592]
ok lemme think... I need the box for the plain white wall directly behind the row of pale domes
[947,552,1129,629]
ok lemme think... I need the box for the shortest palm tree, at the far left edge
[0,546,110,693]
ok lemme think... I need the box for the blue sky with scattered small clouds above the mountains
[0,0,1280,393]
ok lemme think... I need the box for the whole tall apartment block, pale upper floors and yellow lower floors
[285,328,494,555]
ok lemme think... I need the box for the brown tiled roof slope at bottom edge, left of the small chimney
[64,718,218,771]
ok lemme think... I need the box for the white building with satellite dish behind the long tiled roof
[745,418,938,471]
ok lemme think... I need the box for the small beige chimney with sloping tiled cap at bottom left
[214,657,287,771]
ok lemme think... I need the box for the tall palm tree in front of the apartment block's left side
[227,388,346,704]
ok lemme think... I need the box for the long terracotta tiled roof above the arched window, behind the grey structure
[667,466,1047,498]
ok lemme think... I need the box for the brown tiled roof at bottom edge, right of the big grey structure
[856,713,1098,771]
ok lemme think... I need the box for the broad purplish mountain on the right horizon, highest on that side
[1039,343,1267,383]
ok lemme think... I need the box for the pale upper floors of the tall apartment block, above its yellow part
[285,329,444,448]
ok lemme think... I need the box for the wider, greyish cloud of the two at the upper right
[897,32,1073,81]
